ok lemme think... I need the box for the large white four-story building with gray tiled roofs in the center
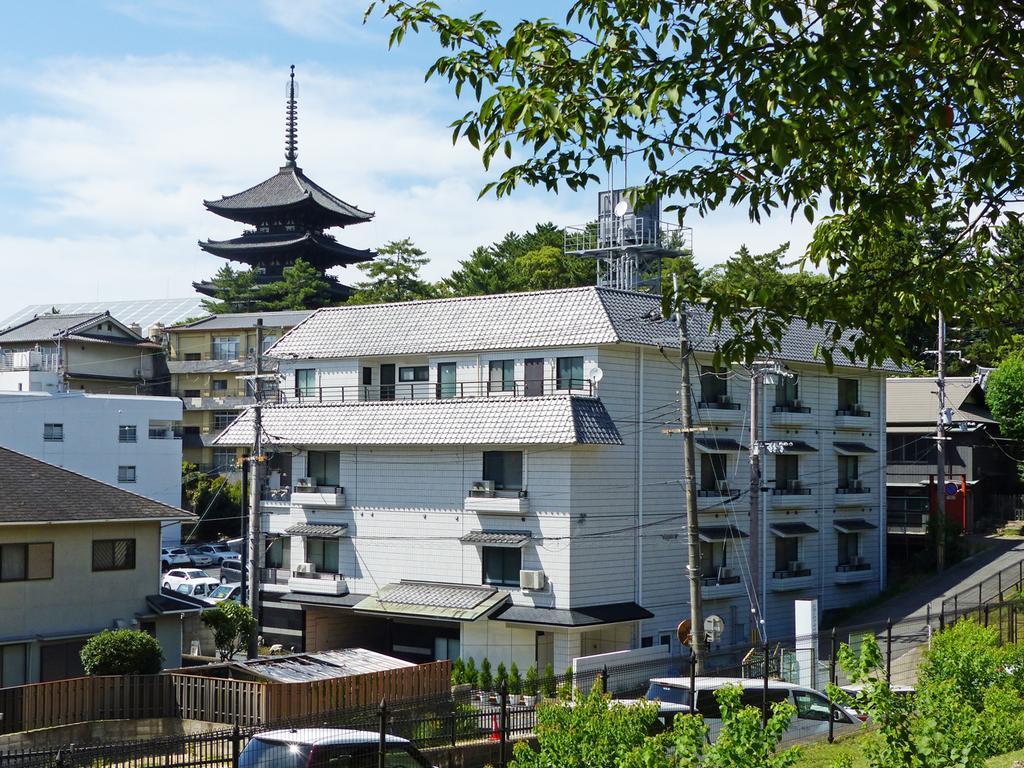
[217,288,885,670]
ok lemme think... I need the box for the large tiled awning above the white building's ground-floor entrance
[354,581,509,622]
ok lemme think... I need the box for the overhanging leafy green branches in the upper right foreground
[368,0,1024,364]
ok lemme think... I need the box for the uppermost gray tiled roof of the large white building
[270,287,901,372]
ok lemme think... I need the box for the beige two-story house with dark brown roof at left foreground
[0,447,199,687]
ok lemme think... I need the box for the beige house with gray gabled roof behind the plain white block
[0,311,169,394]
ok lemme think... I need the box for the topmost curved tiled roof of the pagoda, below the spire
[204,164,374,227]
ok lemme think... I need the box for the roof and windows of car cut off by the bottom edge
[239,728,431,768]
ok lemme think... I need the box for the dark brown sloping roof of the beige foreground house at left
[0,447,195,523]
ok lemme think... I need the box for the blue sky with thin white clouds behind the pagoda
[0,0,808,316]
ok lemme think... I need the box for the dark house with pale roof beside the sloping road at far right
[886,376,1022,536]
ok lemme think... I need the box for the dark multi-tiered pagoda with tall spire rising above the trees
[193,65,376,301]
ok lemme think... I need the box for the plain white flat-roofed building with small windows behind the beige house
[0,391,181,548]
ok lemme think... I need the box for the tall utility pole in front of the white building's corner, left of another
[672,274,705,675]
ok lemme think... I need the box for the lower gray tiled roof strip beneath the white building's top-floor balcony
[214,394,622,445]
